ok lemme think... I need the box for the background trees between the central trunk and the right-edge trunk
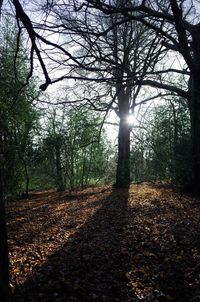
[131,98,192,185]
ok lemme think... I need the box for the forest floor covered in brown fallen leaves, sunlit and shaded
[7,184,200,302]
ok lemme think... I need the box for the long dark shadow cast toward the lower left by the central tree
[13,189,129,302]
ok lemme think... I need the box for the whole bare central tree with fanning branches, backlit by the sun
[62,0,162,187]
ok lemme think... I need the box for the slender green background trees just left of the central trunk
[31,107,111,191]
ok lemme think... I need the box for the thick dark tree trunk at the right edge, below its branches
[190,72,200,192]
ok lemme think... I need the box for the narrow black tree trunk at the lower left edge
[0,166,11,302]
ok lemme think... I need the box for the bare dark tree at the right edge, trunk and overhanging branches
[75,0,200,191]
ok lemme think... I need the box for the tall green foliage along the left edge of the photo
[0,20,38,195]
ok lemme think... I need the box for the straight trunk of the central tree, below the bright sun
[116,118,130,187]
